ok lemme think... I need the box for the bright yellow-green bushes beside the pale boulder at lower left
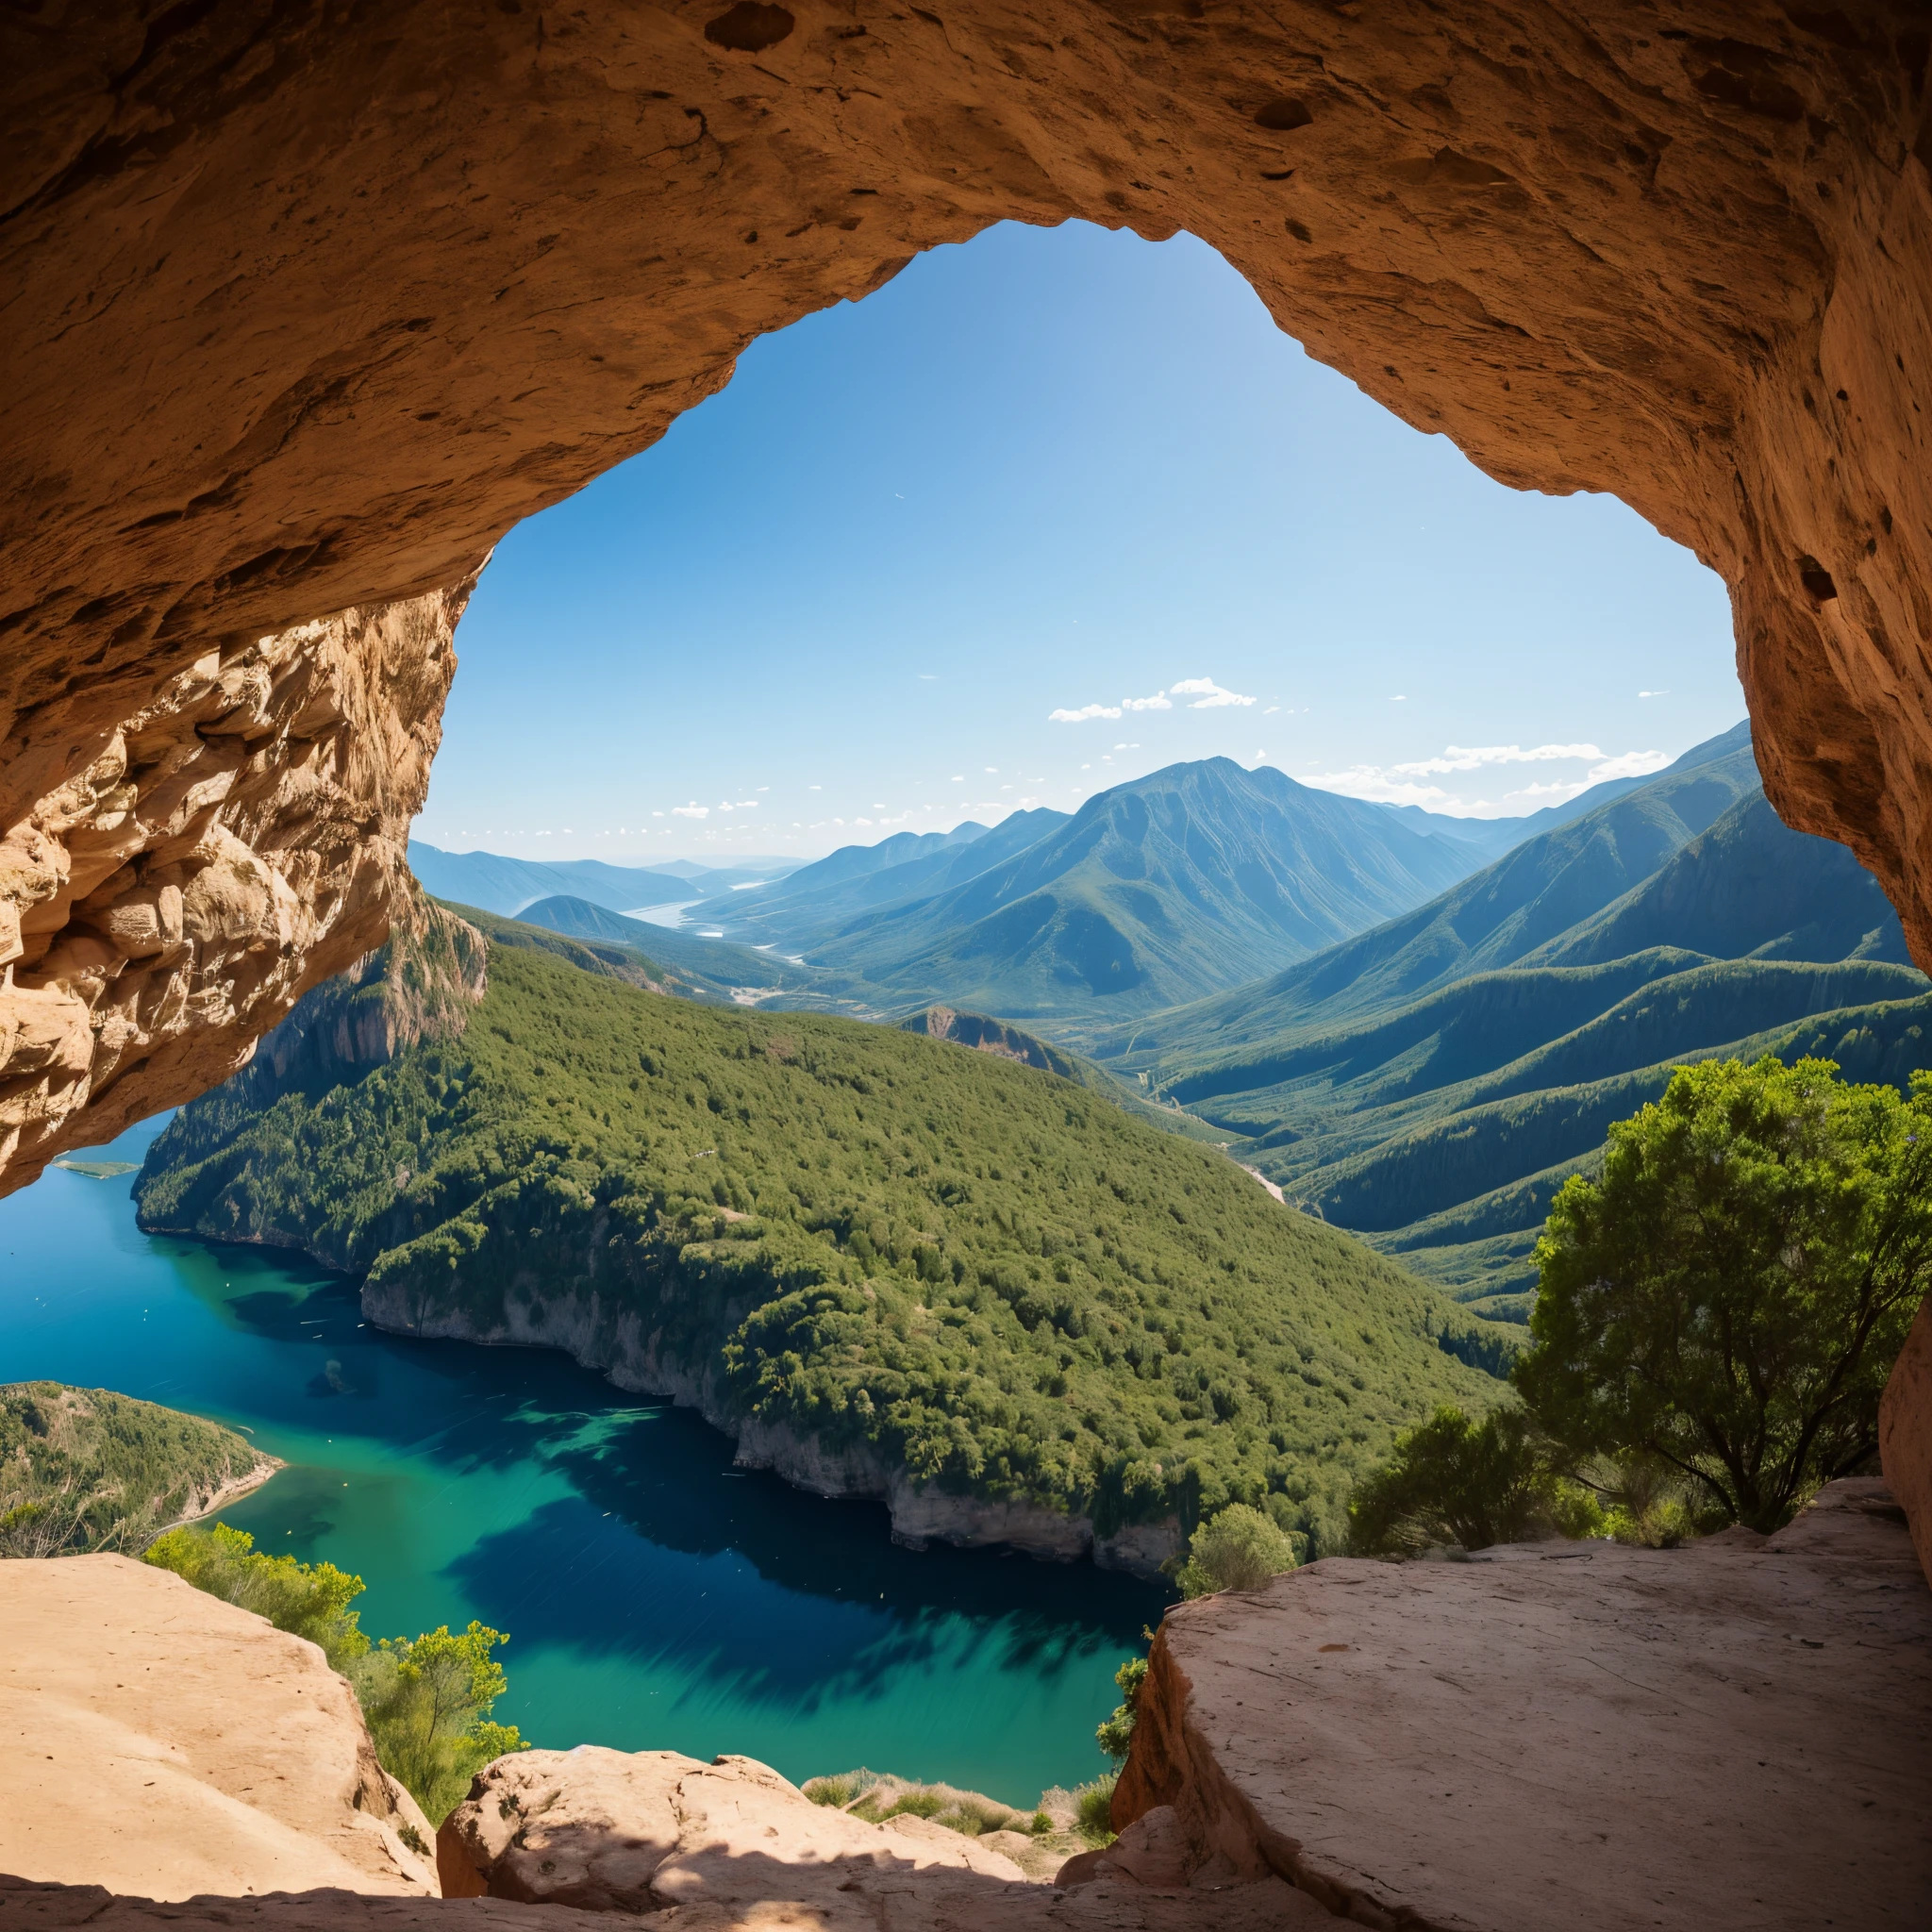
[147,1523,527,1824]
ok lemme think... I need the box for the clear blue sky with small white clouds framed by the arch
[426,225,1744,859]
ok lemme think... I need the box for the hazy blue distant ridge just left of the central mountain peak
[690,806,1066,953]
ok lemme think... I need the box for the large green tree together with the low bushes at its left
[1349,1057,1932,1556]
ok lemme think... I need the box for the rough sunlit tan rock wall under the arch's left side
[0,586,468,1186]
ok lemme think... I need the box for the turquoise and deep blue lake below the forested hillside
[0,1123,1169,1805]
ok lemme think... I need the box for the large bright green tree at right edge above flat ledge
[1515,1058,1932,1532]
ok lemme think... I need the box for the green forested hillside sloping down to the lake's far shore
[137,922,1507,1545]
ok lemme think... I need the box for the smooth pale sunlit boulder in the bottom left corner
[0,1556,437,1901]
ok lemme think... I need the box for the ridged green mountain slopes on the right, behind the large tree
[1101,730,1932,1318]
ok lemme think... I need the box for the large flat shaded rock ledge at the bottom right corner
[1112,1482,1932,1932]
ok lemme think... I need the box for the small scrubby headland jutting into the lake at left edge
[0,1381,278,1557]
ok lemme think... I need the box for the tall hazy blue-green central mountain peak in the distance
[791,758,1468,1025]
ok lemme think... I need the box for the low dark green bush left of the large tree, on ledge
[1349,1407,1598,1557]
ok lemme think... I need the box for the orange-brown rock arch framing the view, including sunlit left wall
[0,0,1932,1182]
